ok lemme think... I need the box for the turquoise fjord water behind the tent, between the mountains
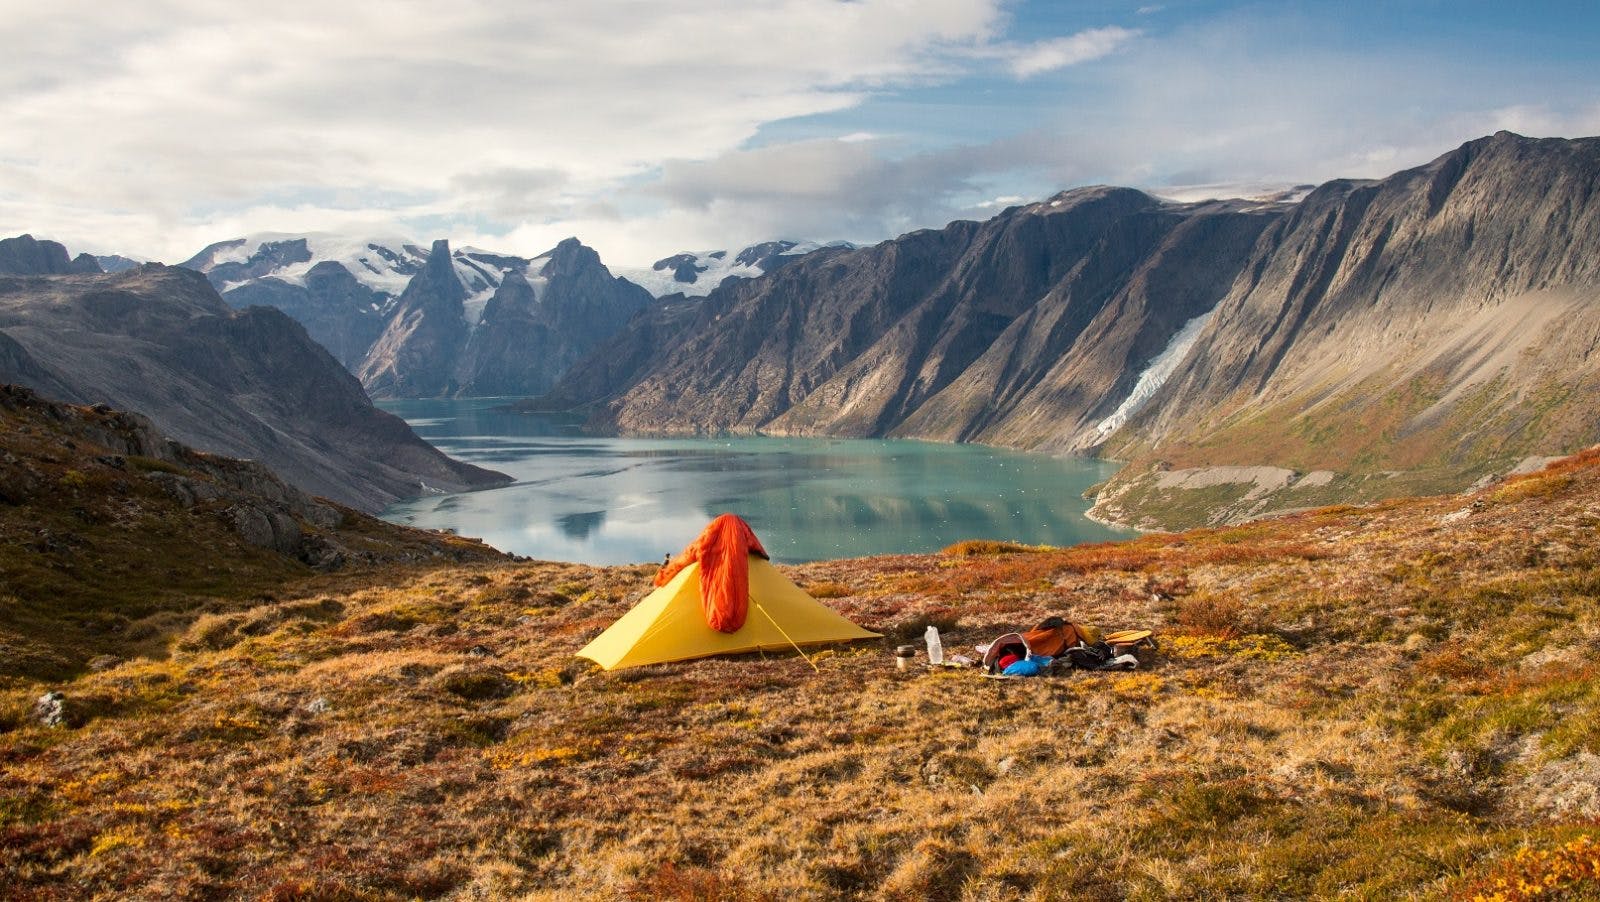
[382,398,1128,565]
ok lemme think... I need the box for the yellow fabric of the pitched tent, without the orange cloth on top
[578,555,880,670]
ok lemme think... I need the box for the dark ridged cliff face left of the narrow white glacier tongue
[550,189,1283,448]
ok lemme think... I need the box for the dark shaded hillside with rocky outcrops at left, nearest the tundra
[0,385,504,686]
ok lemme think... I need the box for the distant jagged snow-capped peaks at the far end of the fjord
[182,233,650,397]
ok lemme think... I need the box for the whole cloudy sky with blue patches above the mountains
[0,0,1600,265]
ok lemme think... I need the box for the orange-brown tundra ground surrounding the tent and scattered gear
[0,454,1600,900]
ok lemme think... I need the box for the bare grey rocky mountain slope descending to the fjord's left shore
[0,265,506,510]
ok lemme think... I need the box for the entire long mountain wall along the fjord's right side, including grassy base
[536,133,1600,525]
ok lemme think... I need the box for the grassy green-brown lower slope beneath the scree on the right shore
[1096,366,1600,529]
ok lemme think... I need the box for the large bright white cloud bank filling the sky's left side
[0,0,1002,259]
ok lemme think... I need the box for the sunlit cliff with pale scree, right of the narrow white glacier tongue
[1109,133,1600,469]
